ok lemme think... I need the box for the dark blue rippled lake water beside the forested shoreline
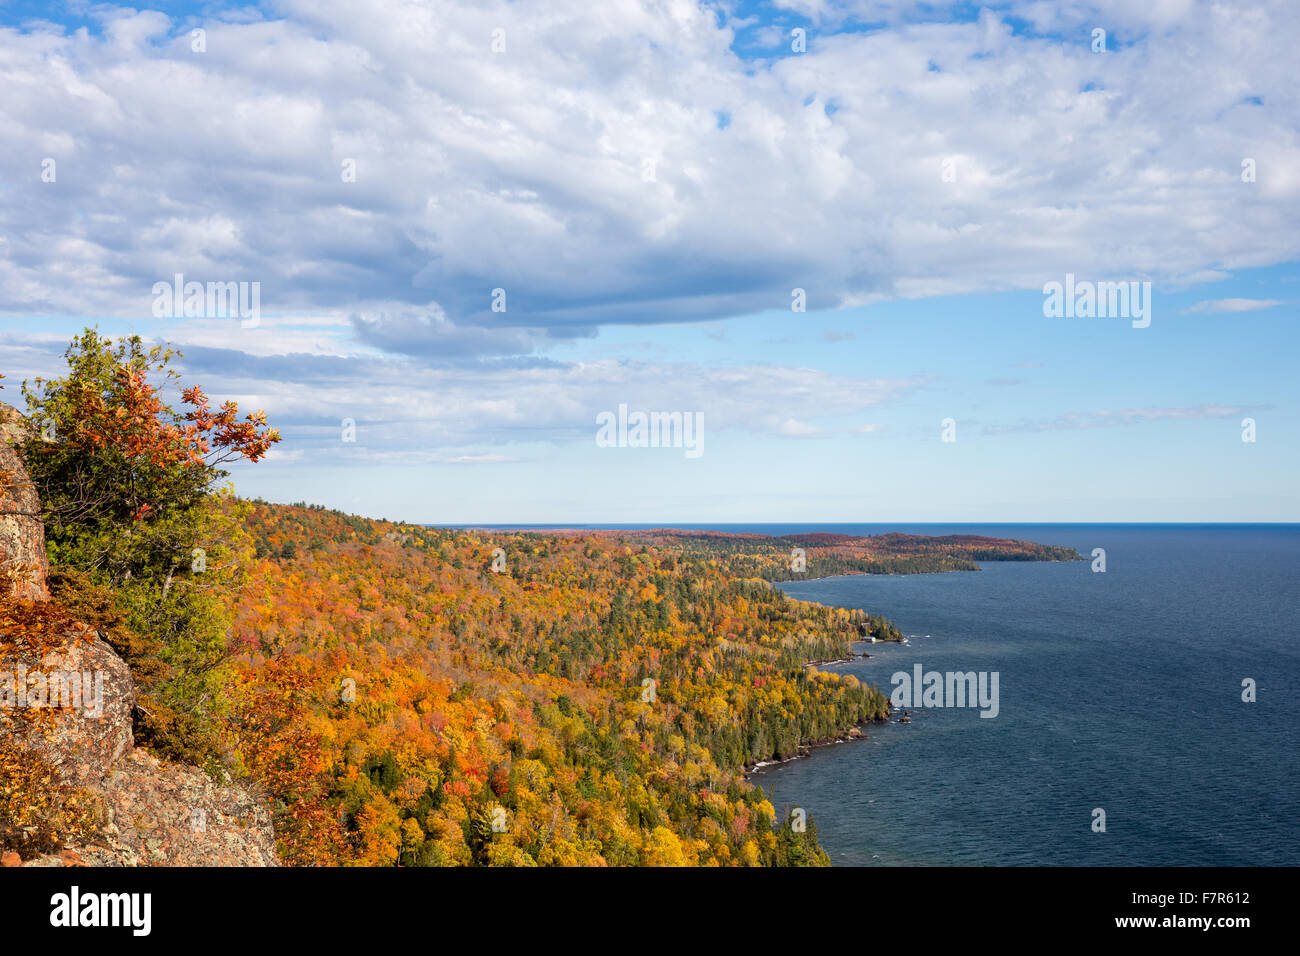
[743,525,1300,865]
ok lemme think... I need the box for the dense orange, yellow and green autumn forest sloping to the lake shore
[229,502,888,865]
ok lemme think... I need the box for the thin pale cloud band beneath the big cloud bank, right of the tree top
[0,323,927,463]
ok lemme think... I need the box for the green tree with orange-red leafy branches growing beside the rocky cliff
[22,329,280,762]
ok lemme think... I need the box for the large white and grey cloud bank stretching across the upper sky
[0,0,1300,359]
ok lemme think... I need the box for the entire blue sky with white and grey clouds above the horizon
[0,0,1300,524]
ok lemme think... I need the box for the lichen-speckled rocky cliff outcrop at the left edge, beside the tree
[0,405,277,866]
